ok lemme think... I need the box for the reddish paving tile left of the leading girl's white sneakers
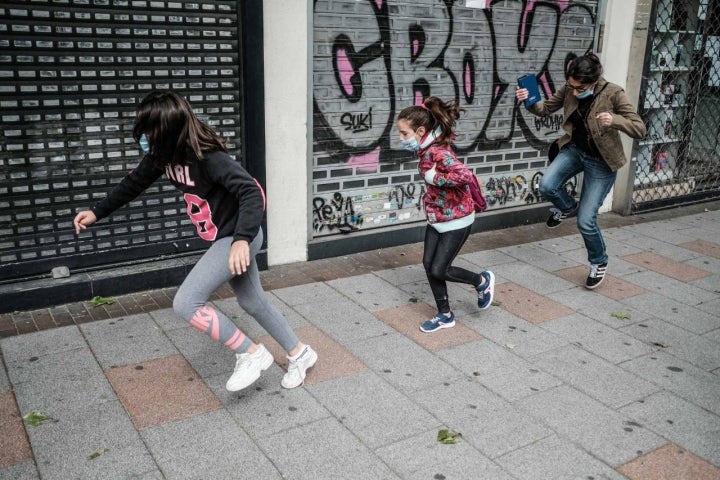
[106,355,222,430]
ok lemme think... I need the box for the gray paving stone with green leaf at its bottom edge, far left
[5,346,116,417]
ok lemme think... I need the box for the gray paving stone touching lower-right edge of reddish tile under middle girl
[438,341,561,401]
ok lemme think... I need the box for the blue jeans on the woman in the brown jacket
[540,144,617,264]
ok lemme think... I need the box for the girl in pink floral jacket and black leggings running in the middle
[397,97,495,332]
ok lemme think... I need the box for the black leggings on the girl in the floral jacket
[423,225,482,313]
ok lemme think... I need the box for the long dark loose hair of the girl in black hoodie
[133,91,227,166]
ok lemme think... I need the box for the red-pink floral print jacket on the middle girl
[418,143,475,224]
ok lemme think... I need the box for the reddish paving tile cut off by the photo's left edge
[0,392,33,466]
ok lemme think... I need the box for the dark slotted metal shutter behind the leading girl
[0,0,241,280]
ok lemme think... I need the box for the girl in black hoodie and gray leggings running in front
[74,91,317,391]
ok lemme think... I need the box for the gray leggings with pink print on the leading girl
[173,230,298,353]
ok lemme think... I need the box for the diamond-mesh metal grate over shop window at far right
[632,0,720,211]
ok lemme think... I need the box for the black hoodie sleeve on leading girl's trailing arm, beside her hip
[206,152,265,242]
